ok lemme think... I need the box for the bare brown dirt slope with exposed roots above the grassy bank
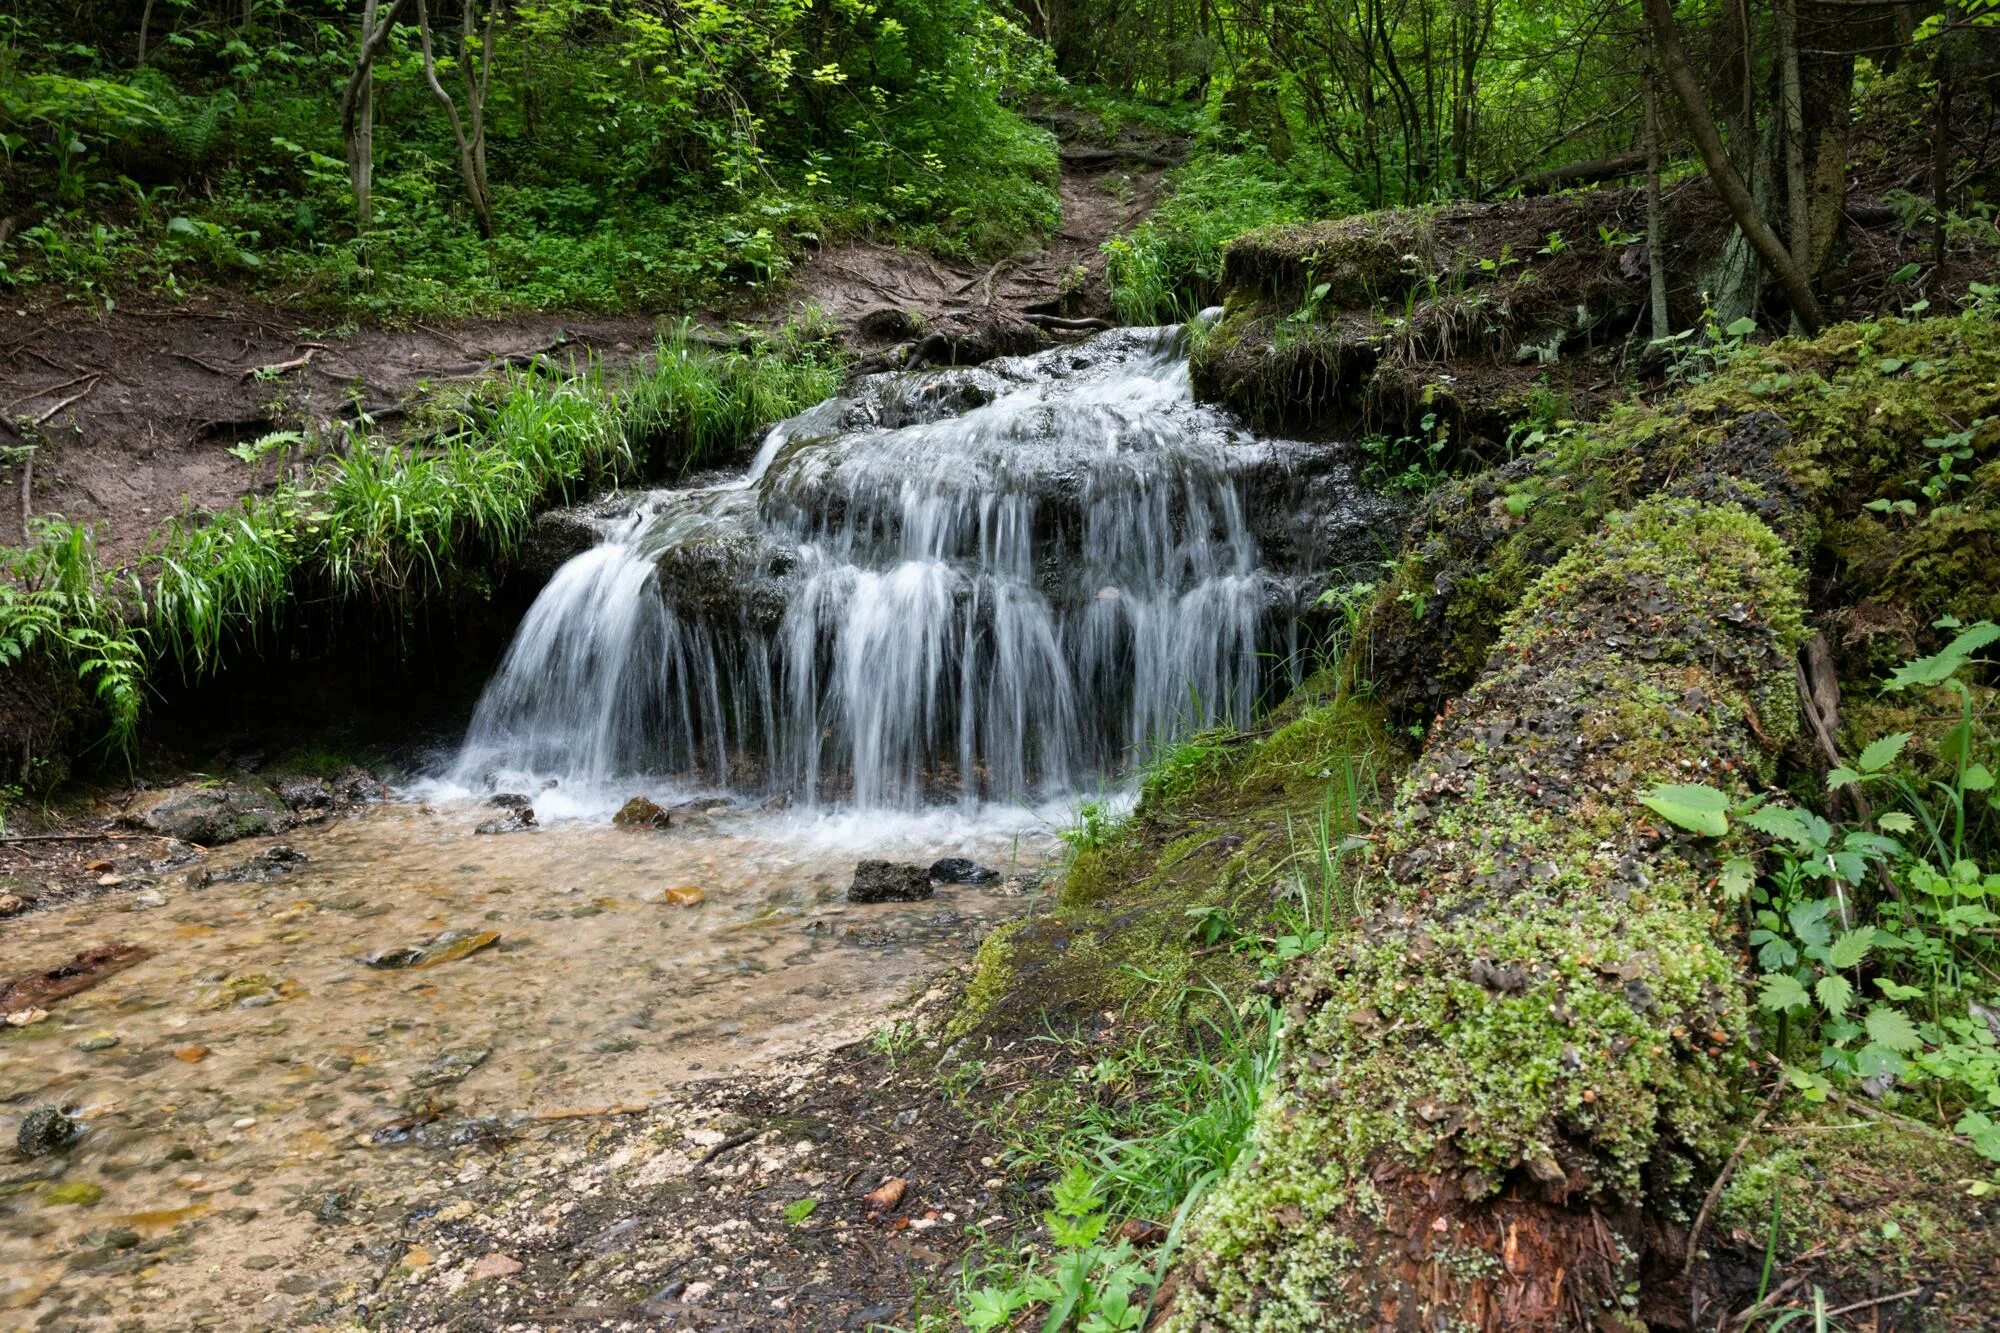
[0,130,1178,562]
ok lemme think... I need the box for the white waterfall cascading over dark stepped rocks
[450,330,1382,807]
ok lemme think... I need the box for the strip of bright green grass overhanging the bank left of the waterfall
[0,324,840,789]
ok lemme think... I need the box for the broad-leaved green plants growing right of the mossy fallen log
[1640,620,2000,1163]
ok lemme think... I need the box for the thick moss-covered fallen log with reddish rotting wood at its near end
[1166,466,1804,1329]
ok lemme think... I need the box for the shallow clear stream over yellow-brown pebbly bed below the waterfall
[0,805,1050,1327]
